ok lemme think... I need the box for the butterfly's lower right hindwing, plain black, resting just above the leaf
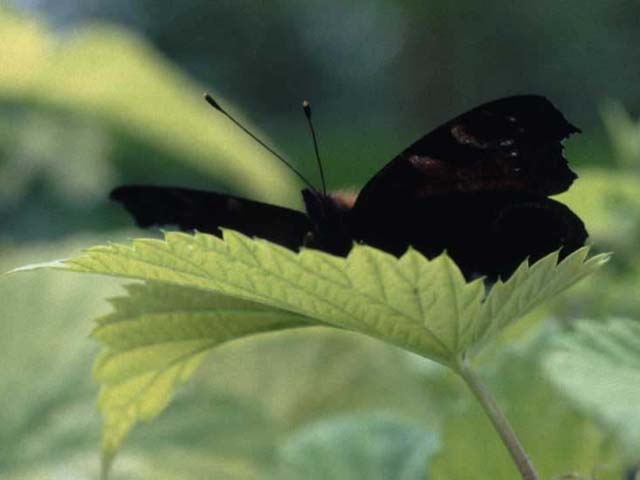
[355,192,587,280]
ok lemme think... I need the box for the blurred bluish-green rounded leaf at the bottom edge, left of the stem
[276,414,438,480]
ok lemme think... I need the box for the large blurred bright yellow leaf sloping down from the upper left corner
[0,8,297,207]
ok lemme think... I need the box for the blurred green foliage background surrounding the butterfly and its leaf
[0,0,640,480]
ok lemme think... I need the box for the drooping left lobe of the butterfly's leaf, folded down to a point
[93,283,309,466]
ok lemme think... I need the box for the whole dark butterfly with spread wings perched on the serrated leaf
[111,95,587,279]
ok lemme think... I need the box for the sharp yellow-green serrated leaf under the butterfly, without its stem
[17,231,607,470]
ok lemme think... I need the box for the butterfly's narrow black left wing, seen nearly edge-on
[110,185,311,249]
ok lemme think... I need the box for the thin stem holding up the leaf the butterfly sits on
[458,360,538,480]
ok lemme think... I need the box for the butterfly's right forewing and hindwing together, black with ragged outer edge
[349,95,586,277]
